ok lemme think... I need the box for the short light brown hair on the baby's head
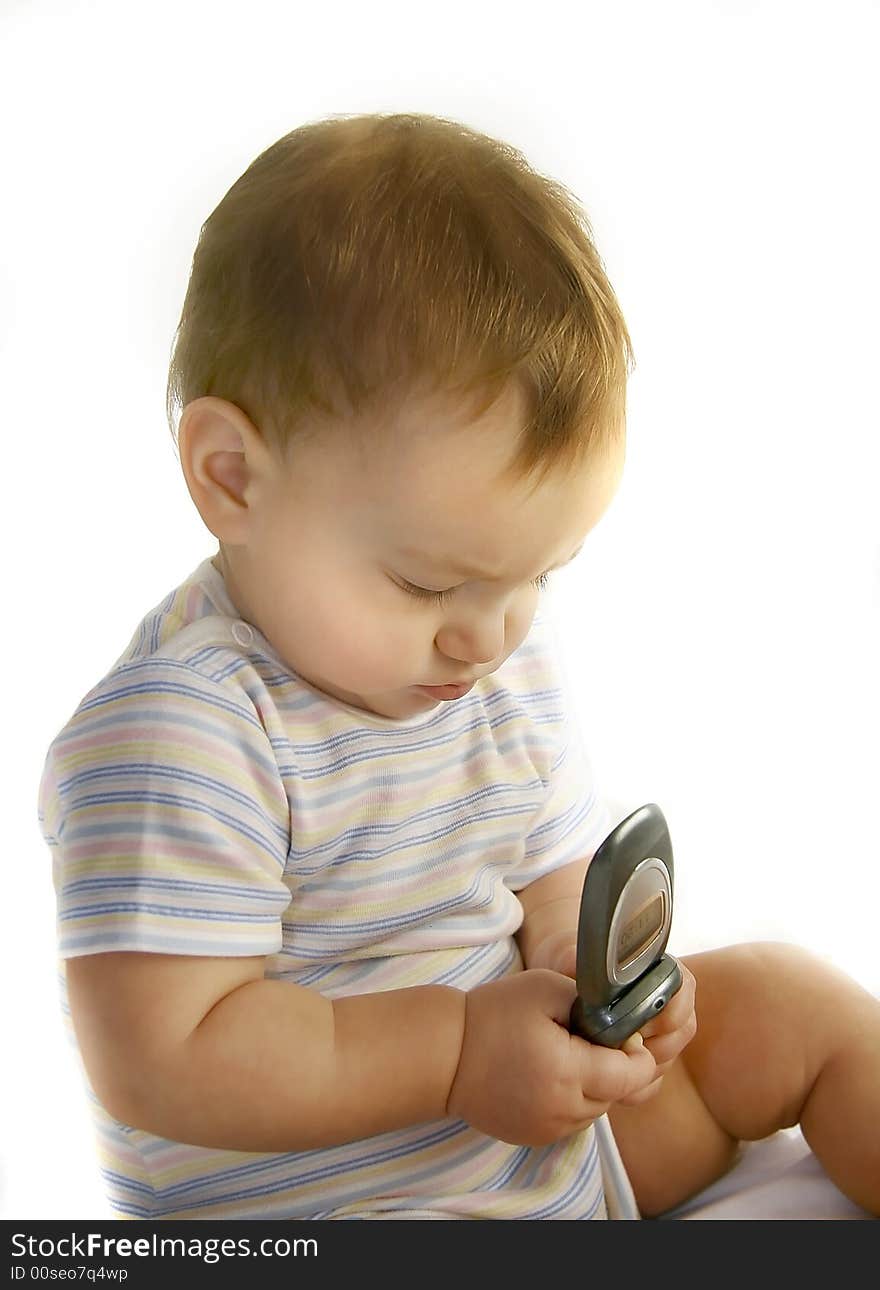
[166,114,634,492]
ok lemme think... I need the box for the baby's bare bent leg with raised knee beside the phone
[609,944,880,1216]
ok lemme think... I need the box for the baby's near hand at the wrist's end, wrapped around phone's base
[446,969,658,1147]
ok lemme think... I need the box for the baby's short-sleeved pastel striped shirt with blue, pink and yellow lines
[39,560,626,1219]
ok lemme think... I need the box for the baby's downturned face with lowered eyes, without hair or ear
[215,390,623,719]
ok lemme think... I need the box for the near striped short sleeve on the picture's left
[39,658,290,958]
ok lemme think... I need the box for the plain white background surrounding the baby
[0,0,880,1218]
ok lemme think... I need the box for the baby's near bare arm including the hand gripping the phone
[67,952,655,1152]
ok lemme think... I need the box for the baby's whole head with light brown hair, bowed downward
[168,115,632,719]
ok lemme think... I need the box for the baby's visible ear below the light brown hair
[177,395,266,546]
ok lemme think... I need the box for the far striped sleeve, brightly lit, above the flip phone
[506,617,612,891]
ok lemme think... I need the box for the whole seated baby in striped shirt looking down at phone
[40,115,880,1219]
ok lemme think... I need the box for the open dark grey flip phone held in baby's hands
[569,802,681,1047]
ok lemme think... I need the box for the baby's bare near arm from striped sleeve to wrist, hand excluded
[67,952,465,1151]
